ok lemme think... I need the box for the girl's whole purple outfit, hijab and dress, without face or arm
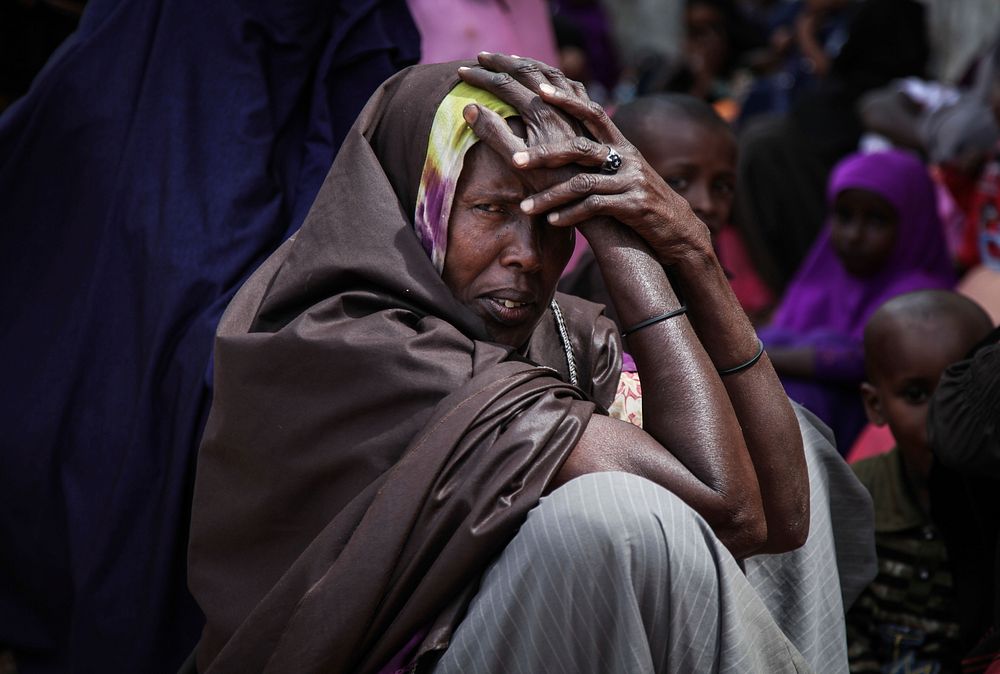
[760,150,955,452]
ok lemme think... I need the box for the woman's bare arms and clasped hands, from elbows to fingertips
[454,53,809,557]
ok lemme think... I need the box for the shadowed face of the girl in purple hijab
[830,189,899,278]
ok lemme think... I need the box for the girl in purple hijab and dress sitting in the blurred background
[760,150,955,452]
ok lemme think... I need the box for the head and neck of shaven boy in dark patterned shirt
[861,320,968,478]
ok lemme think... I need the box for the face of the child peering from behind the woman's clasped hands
[636,115,736,236]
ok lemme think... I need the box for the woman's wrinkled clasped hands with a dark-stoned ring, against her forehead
[459,53,711,264]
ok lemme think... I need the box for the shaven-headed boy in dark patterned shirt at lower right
[847,290,992,674]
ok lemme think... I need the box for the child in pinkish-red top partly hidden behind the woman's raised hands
[559,94,774,322]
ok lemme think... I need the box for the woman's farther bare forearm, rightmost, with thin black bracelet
[671,244,809,552]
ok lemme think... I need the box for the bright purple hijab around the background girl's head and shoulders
[770,150,955,339]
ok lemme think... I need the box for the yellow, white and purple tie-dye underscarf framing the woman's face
[413,82,518,273]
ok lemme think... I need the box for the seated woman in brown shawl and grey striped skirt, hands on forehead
[182,55,860,672]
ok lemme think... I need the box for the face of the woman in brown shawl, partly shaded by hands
[442,138,574,348]
